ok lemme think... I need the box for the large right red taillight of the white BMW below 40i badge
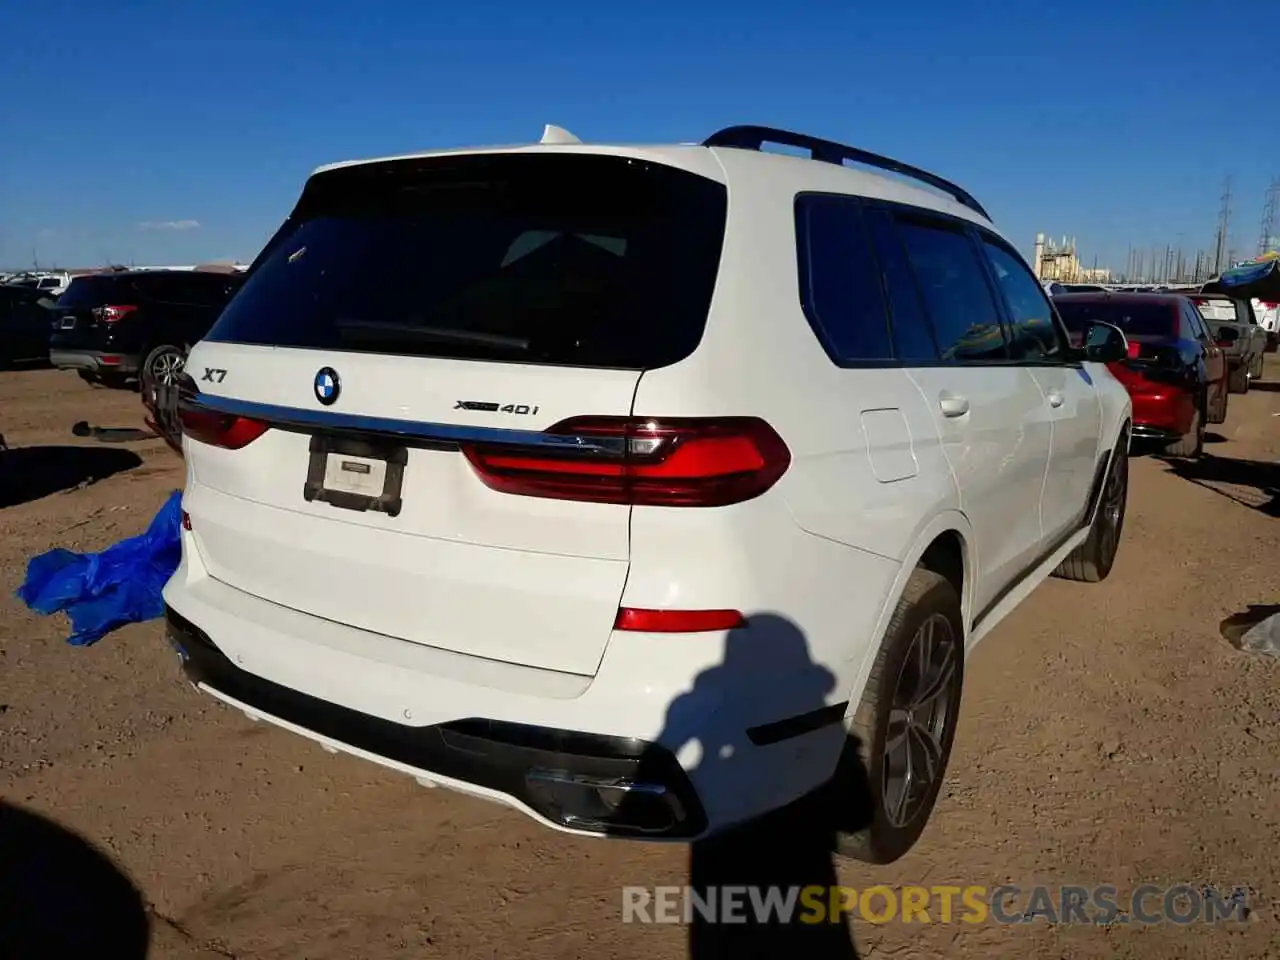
[463,417,791,507]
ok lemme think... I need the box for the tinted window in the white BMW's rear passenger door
[899,220,1007,361]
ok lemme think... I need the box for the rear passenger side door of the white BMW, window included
[895,211,1052,618]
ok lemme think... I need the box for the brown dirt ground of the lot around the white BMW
[0,358,1280,960]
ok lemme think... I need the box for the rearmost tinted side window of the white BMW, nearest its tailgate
[796,197,893,361]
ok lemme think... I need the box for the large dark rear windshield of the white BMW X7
[206,154,726,370]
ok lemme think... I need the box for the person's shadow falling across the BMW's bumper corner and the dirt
[618,613,873,960]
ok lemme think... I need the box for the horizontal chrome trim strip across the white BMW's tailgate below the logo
[180,393,626,456]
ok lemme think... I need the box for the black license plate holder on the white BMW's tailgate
[302,434,408,517]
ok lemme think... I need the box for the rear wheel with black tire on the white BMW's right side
[833,570,964,864]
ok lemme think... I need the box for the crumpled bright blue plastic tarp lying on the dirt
[18,490,182,646]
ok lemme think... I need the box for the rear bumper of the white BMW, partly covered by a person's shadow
[164,542,847,841]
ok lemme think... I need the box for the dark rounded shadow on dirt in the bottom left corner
[0,801,151,960]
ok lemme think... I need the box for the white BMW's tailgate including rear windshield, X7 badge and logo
[177,154,726,675]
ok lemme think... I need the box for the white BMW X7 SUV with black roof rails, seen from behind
[165,120,1130,863]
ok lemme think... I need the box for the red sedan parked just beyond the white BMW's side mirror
[1053,293,1229,457]
